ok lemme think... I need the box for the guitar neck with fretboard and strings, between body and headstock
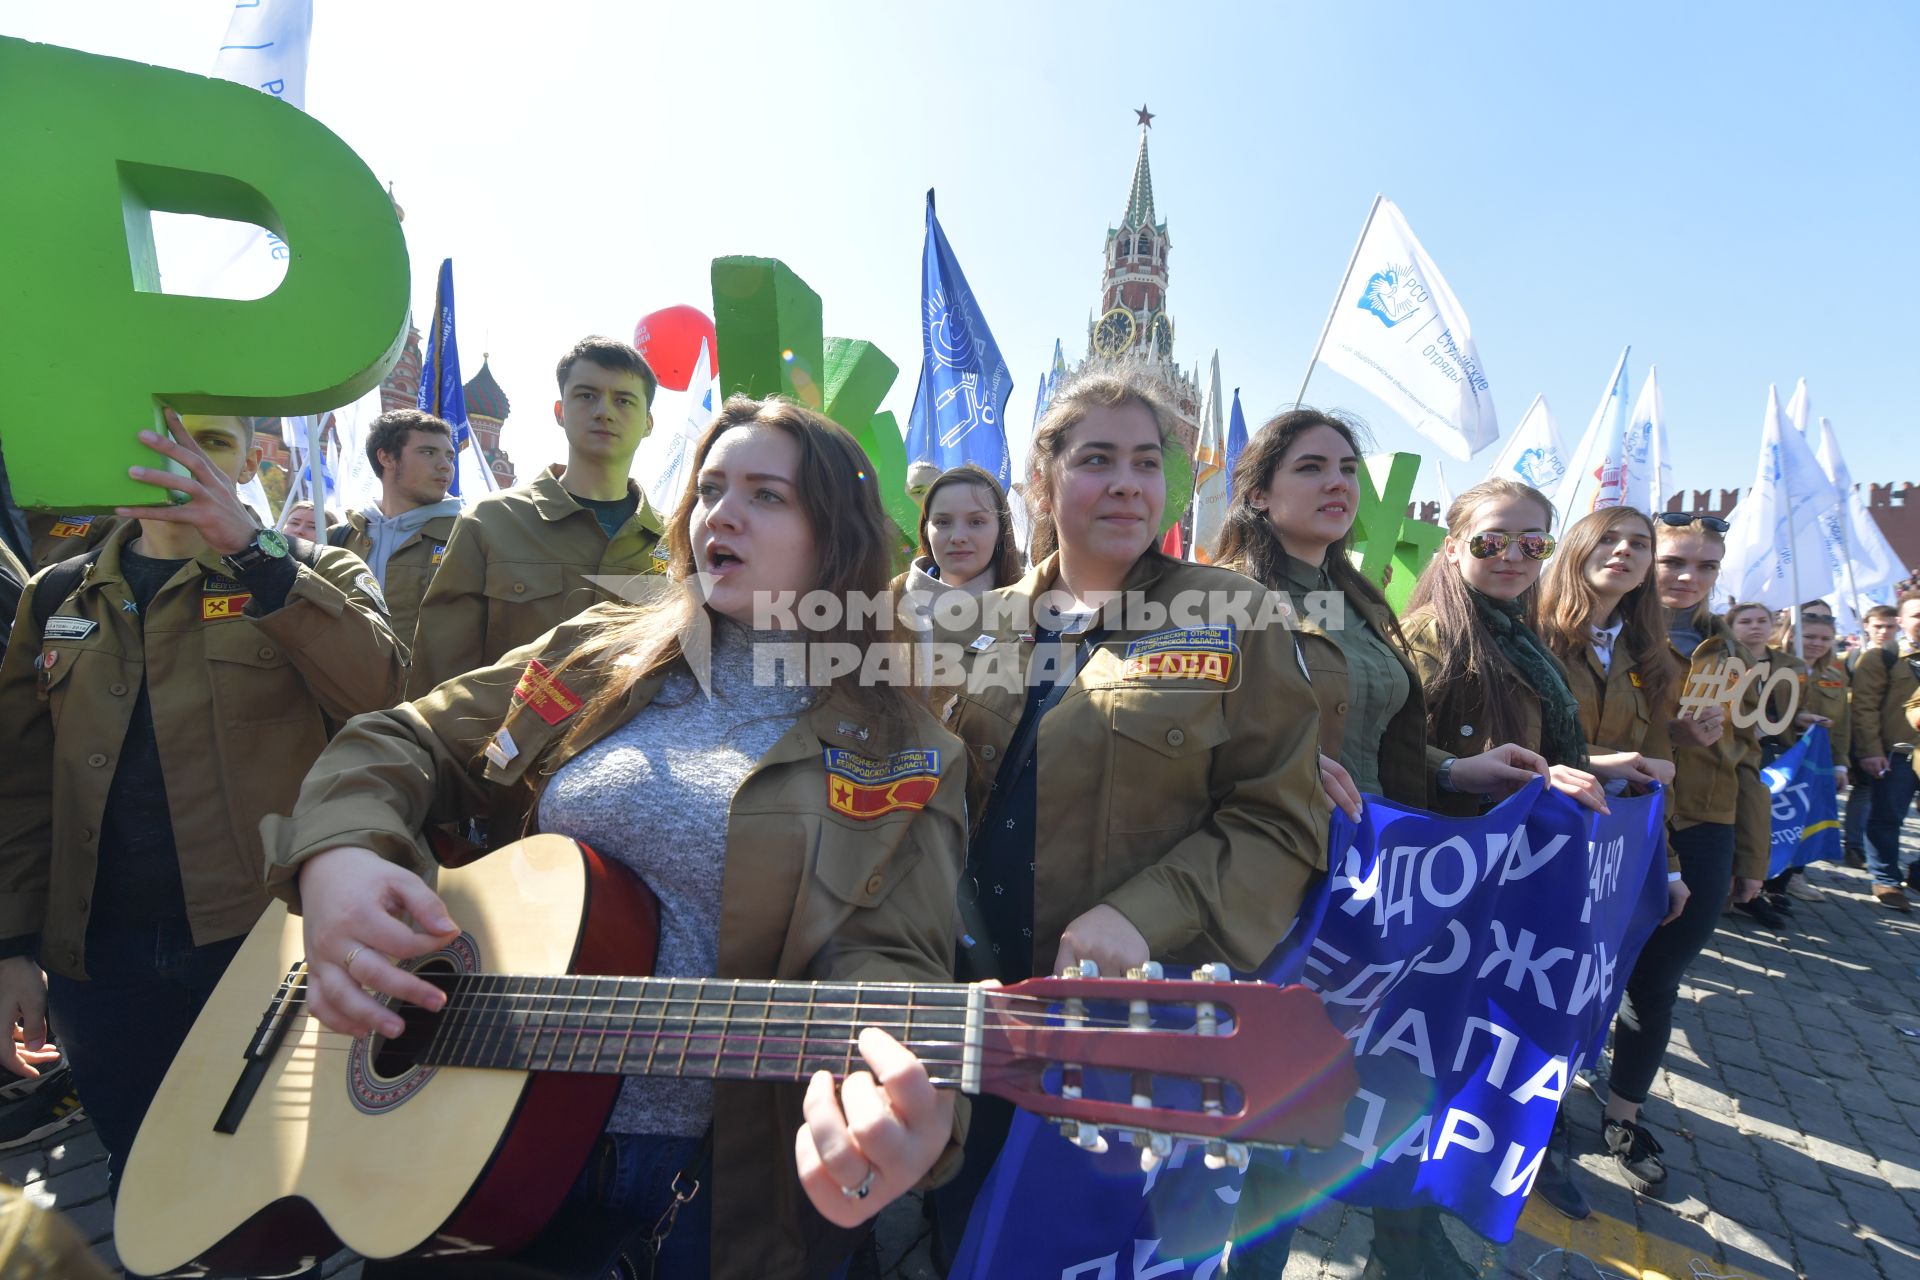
[405,973,985,1092]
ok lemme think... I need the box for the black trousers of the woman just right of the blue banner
[1607,823,1734,1103]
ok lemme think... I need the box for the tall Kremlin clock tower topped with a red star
[1087,106,1200,453]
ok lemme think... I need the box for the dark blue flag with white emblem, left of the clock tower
[906,190,1014,486]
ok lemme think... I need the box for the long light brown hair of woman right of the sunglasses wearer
[1540,507,1674,706]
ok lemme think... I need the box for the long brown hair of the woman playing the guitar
[557,395,906,748]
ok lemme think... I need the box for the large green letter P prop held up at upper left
[0,36,407,510]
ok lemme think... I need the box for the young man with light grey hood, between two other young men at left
[326,409,461,667]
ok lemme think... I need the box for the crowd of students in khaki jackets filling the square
[0,340,1920,1280]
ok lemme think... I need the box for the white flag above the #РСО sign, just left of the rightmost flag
[1720,386,1837,608]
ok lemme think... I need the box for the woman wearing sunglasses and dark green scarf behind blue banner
[1369,478,1607,1280]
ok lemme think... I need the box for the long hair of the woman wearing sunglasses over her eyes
[1407,476,1553,743]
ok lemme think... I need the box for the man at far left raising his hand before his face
[0,411,405,1180]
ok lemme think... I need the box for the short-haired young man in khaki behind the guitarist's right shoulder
[407,338,660,699]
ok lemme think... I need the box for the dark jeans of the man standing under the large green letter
[46,919,244,1196]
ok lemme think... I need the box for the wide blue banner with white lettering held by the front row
[952,783,1667,1280]
